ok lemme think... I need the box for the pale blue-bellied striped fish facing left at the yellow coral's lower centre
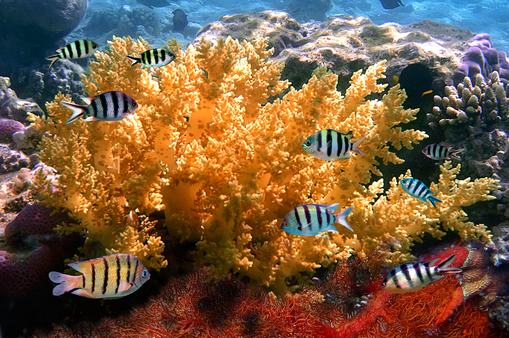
[281,203,353,236]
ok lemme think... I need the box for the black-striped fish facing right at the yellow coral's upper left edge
[60,90,138,124]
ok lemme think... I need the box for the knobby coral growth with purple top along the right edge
[427,35,509,231]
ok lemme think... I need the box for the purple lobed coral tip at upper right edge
[453,33,509,86]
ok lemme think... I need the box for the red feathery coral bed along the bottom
[33,246,506,338]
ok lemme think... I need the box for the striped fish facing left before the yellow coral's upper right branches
[302,129,365,161]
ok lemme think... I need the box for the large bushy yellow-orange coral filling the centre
[27,38,494,292]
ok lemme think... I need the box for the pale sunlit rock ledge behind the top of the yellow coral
[195,11,473,90]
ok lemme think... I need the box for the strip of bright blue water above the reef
[81,0,509,51]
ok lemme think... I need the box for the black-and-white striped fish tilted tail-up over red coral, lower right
[381,254,461,293]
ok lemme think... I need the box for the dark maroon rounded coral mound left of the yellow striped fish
[0,204,79,299]
